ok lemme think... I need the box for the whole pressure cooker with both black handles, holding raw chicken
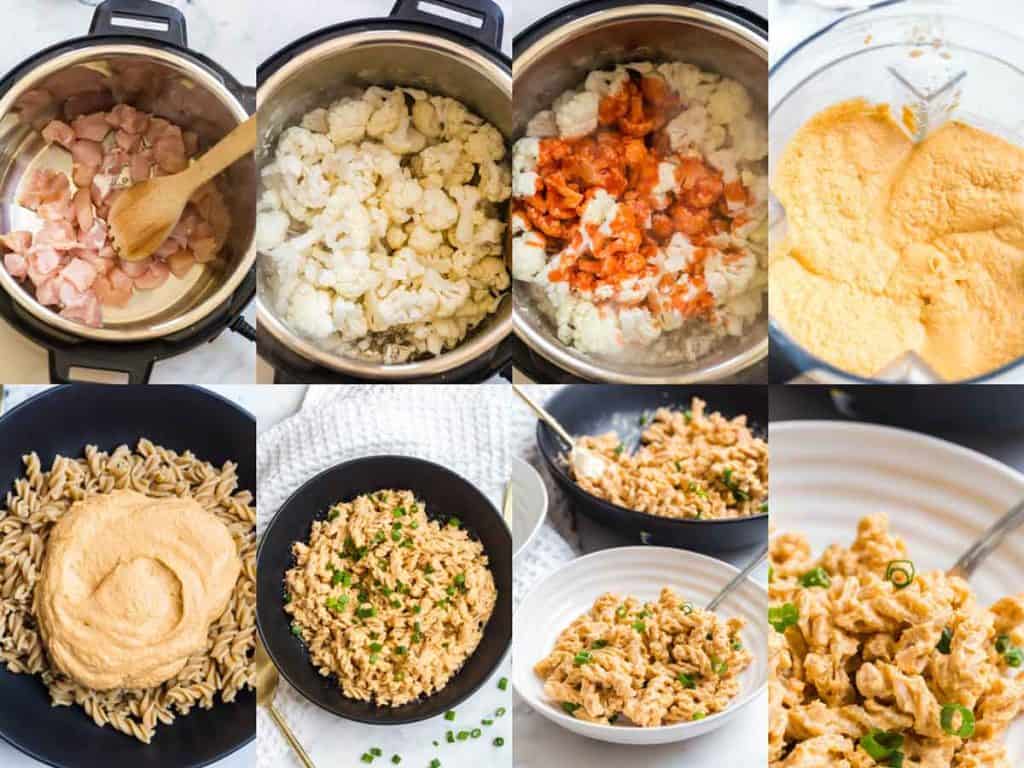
[0,0,256,383]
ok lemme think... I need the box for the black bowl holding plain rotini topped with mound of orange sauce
[0,384,256,768]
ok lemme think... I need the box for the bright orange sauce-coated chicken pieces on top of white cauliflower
[513,74,749,317]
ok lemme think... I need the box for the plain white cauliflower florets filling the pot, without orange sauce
[256,86,512,364]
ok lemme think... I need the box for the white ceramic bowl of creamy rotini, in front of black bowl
[512,547,768,744]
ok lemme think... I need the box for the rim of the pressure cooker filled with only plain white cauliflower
[255,17,513,382]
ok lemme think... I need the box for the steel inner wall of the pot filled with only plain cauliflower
[256,34,512,366]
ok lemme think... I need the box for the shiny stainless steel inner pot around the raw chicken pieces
[0,46,256,338]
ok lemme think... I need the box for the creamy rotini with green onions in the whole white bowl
[534,588,753,727]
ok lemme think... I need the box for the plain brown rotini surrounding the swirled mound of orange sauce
[0,439,256,743]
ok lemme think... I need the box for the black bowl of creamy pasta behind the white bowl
[537,384,768,552]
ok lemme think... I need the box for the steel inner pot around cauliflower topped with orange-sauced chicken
[514,15,768,378]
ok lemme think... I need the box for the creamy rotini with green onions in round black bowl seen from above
[285,490,498,707]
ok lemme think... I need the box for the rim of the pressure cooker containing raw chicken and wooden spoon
[0,35,256,344]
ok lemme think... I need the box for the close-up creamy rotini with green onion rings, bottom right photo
[768,514,1024,768]
